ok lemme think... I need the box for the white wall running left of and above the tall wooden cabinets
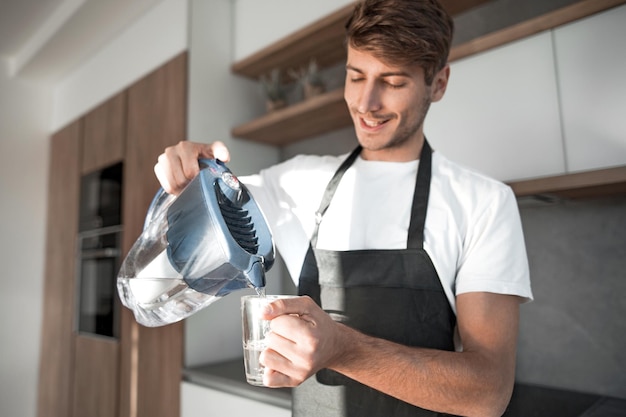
[0,0,188,417]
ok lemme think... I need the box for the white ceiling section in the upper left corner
[0,0,163,83]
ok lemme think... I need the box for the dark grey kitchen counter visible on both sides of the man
[183,359,626,417]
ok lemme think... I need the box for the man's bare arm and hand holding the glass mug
[261,292,520,417]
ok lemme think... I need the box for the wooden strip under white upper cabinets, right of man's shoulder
[509,166,626,198]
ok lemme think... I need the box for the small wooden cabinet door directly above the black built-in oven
[82,92,126,174]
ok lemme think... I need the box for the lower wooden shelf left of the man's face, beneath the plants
[232,88,352,146]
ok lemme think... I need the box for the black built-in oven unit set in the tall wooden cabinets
[75,163,122,338]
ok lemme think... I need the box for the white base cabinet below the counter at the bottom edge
[180,382,291,417]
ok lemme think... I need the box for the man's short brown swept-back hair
[346,0,454,85]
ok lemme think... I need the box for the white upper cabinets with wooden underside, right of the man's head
[426,6,626,187]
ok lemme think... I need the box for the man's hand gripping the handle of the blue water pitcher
[154,141,230,195]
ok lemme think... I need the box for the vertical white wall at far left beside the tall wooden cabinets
[0,61,51,417]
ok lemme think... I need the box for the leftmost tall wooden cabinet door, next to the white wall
[38,121,82,417]
